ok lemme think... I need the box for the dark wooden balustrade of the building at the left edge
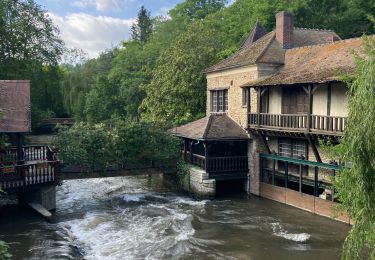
[0,161,58,189]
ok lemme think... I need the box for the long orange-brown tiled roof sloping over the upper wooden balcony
[243,38,363,86]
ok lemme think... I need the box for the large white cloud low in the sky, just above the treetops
[49,13,134,57]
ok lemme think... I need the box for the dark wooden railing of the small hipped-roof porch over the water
[185,152,248,173]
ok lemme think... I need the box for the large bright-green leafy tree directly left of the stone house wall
[140,21,220,125]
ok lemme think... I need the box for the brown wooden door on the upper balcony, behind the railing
[281,86,309,114]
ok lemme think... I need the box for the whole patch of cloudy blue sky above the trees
[36,0,183,58]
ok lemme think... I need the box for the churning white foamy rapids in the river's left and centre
[58,178,206,260]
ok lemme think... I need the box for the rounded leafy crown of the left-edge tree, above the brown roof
[0,0,63,79]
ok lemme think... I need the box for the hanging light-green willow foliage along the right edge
[334,38,375,259]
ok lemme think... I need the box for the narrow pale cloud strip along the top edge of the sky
[71,0,137,12]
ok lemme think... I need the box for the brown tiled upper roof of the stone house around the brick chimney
[205,28,340,73]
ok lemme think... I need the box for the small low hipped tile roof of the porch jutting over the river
[168,114,248,140]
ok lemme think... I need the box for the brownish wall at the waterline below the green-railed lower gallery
[260,183,350,224]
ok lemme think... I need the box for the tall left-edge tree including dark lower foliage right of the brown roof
[0,0,64,127]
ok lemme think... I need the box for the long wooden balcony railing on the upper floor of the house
[248,113,347,136]
